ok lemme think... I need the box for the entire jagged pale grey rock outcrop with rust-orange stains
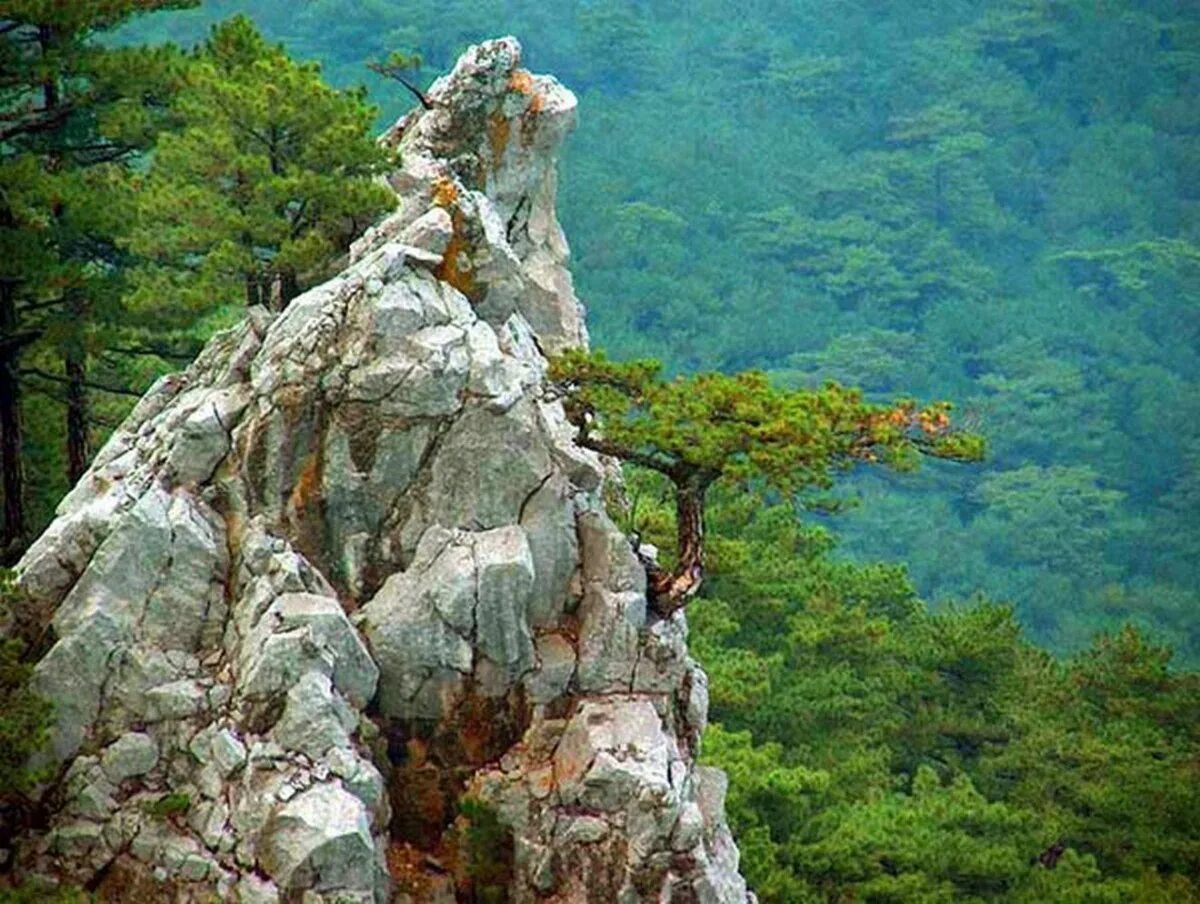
[7,38,746,904]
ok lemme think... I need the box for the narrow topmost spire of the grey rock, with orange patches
[353,37,587,353]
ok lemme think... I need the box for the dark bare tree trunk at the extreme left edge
[0,280,25,564]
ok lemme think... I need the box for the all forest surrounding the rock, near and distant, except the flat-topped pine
[0,0,1200,902]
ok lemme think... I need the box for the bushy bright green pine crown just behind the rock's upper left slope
[130,16,394,311]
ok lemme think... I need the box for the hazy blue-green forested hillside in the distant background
[117,0,1200,663]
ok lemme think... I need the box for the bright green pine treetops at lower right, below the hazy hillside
[630,472,1200,904]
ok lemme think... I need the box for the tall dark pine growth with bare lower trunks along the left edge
[0,0,197,561]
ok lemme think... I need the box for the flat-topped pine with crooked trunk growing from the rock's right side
[548,349,984,615]
